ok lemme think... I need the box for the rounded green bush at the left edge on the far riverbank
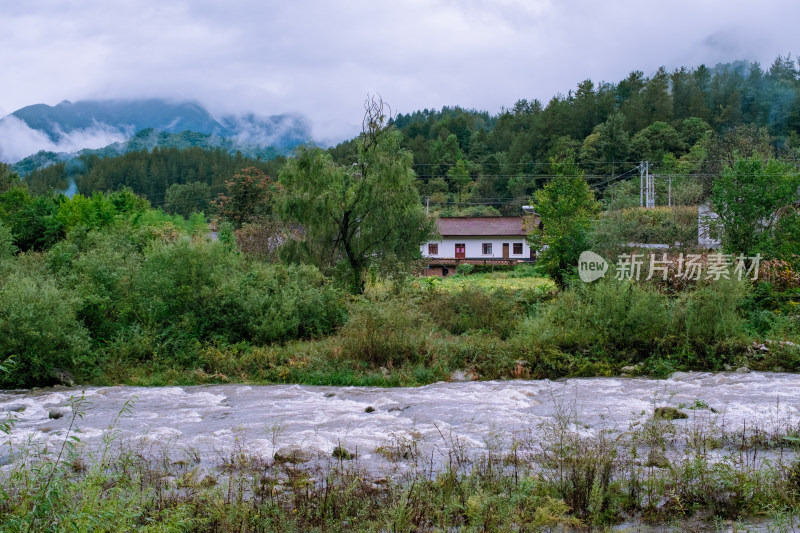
[0,273,89,387]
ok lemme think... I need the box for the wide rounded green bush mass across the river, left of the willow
[123,239,342,353]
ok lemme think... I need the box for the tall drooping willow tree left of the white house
[279,98,433,293]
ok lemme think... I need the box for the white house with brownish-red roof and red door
[420,217,534,274]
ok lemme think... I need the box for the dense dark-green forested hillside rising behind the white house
[374,56,800,213]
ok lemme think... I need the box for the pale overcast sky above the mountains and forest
[0,0,800,139]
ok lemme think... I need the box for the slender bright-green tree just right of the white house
[528,159,600,287]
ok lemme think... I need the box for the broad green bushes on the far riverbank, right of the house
[512,274,748,368]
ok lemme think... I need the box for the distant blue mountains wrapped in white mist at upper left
[0,99,311,167]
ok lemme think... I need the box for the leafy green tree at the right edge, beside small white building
[711,156,800,254]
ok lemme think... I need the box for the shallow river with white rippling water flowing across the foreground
[0,372,800,470]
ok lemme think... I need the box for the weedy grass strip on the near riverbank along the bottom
[0,388,800,532]
